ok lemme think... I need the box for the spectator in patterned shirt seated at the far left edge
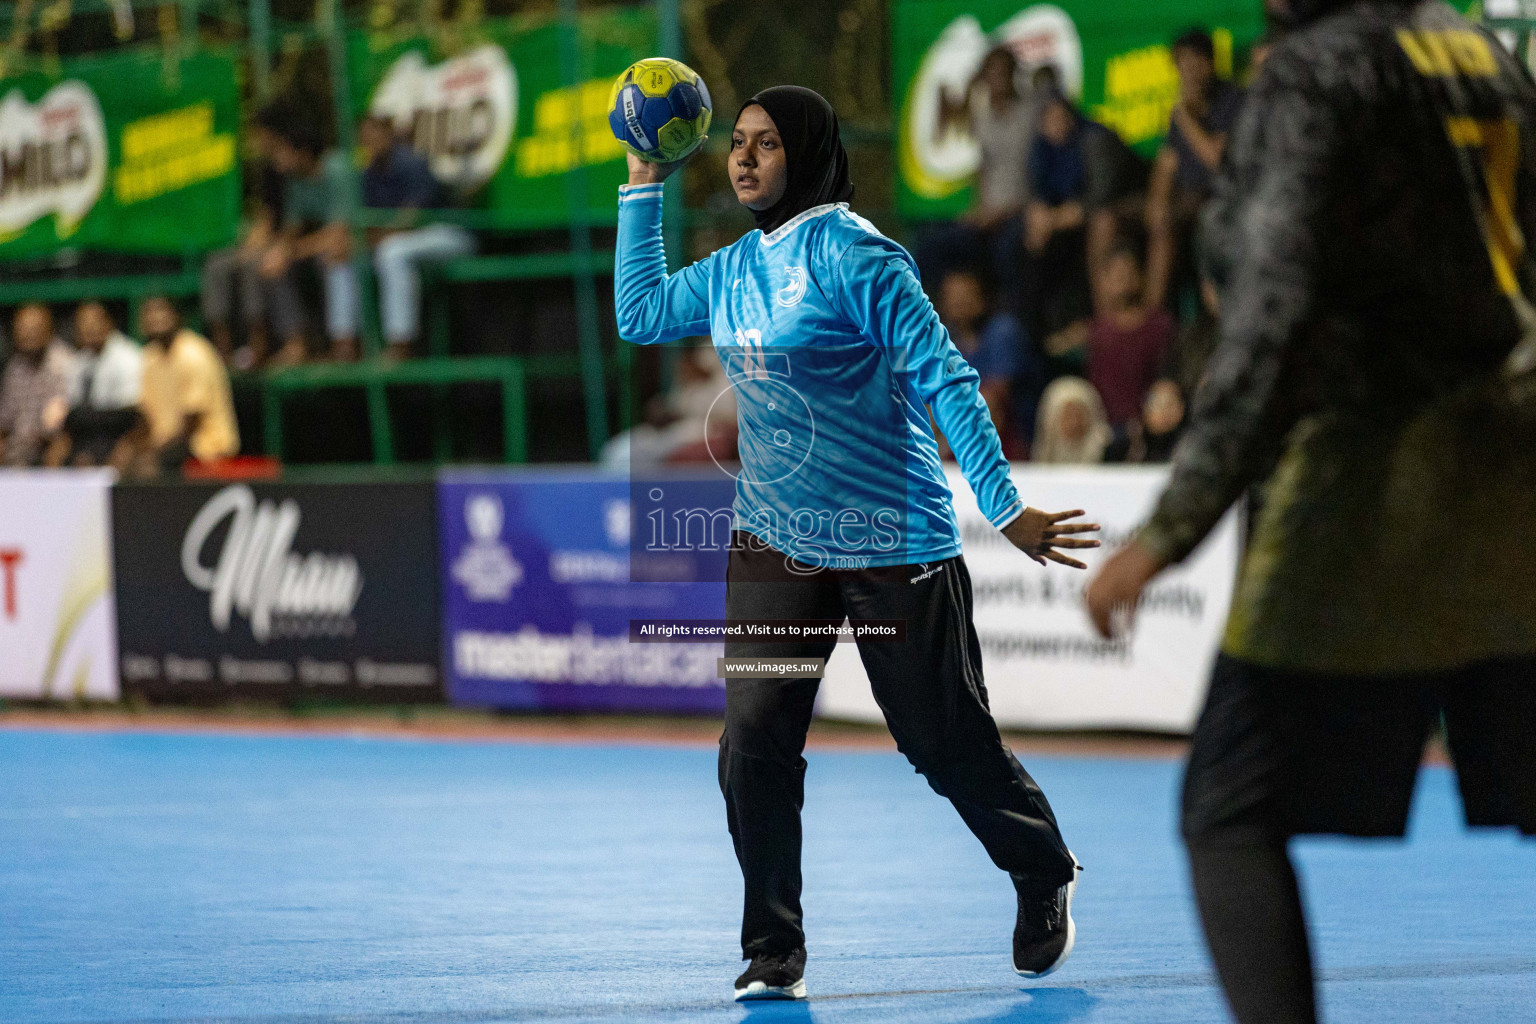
[0,302,74,467]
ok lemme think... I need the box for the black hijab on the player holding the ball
[736,86,854,233]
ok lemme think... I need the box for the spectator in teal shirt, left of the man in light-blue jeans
[261,112,356,365]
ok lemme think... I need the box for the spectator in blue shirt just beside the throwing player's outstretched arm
[938,270,1043,457]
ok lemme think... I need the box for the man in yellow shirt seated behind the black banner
[138,296,240,474]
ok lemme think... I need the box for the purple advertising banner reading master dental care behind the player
[438,470,731,714]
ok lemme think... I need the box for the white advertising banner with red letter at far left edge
[0,470,118,700]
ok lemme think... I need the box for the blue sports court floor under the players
[0,729,1536,1024]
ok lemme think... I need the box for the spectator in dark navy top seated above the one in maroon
[1025,92,1146,342]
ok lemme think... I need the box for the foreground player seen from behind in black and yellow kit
[1087,0,1536,1024]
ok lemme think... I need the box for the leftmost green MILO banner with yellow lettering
[0,51,240,259]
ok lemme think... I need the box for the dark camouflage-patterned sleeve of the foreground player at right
[1138,48,1342,562]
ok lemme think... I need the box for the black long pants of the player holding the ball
[720,536,1075,958]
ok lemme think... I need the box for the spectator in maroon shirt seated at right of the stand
[1084,246,1174,430]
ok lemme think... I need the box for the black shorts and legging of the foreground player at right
[1183,656,1536,1024]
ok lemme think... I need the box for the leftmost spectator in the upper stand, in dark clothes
[203,104,293,370]
